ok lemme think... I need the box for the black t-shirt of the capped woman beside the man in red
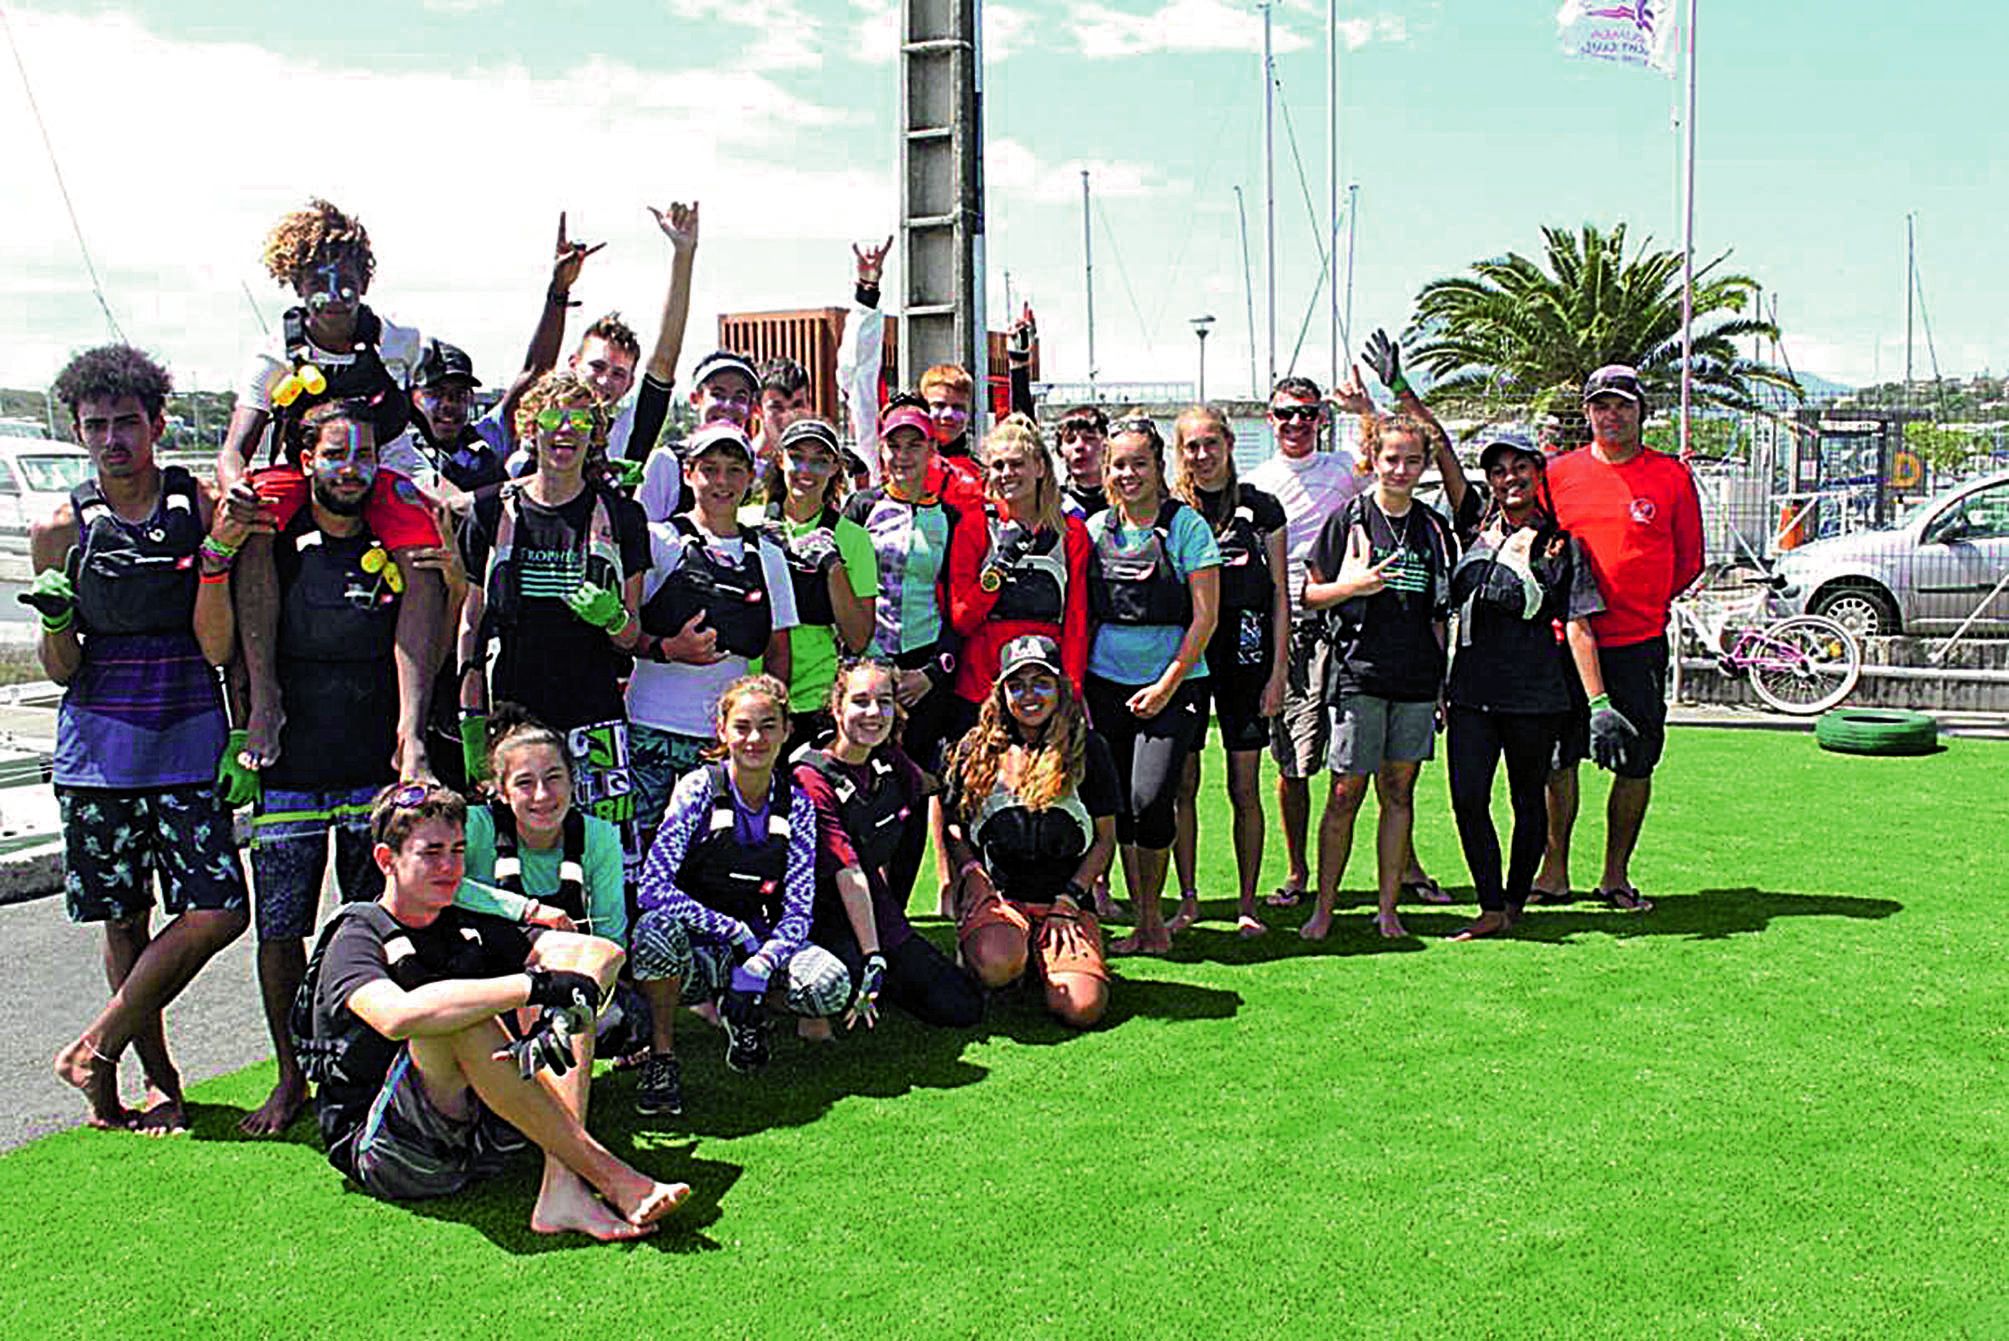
[1446,527,1605,712]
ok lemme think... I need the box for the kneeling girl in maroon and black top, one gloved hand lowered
[794,661,984,1029]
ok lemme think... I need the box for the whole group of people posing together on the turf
[22,201,1702,1238]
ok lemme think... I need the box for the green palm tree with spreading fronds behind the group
[1408,223,1800,430]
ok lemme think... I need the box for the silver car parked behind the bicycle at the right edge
[1778,472,2009,637]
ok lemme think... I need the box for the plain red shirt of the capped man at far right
[1549,446,1702,647]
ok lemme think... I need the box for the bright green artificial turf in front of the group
[0,730,2009,1341]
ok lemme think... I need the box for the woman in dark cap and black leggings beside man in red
[1444,436,1605,941]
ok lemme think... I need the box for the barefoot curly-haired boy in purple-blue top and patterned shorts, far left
[34,346,249,1132]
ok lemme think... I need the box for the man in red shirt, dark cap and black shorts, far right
[1535,364,1702,913]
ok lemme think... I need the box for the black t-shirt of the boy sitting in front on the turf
[313,903,530,1172]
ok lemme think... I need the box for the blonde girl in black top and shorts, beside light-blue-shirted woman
[1171,406,1290,937]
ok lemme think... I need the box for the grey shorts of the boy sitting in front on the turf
[356,1049,530,1202]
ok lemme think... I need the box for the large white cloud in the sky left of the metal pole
[0,8,898,386]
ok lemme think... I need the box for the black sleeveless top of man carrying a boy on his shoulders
[263,507,400,792]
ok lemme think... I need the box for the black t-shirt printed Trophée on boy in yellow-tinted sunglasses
[460,485,649,732]
